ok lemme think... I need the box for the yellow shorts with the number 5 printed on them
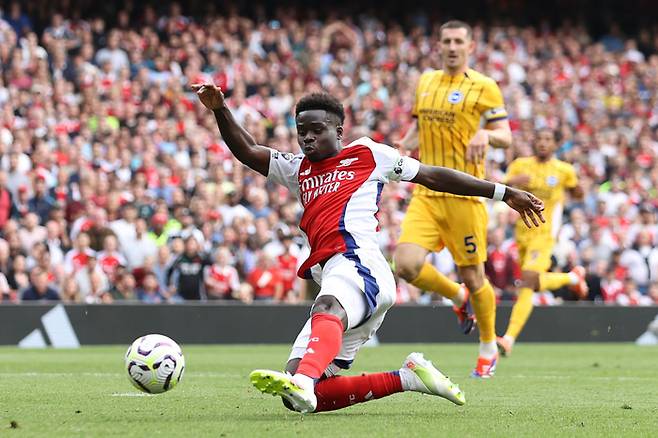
[398,195,489,266]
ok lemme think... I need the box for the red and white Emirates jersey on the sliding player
[268,137,420,278]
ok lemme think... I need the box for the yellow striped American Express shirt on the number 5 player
[412,69,507,196]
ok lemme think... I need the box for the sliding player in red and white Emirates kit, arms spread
[193,84,543,412]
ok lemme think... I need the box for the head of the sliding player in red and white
[295,93,345,161]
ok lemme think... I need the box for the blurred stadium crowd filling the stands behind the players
[0,2,658,305]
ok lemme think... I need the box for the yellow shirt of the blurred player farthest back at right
[505,157,578,240]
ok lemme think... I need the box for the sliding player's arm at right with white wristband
[411,164,545,228]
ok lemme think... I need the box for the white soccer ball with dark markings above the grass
[126,335,185,394]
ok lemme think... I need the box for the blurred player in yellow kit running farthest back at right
[497,129,587,356]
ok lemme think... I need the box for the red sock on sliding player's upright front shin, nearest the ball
[297,313,343,379]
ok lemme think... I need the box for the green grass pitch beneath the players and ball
[0,344,658,437]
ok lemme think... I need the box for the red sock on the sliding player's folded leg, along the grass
[315,371,402,412]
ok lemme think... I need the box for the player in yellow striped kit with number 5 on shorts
[394,21,512,377]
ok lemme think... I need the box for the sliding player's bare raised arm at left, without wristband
[192,84,270,176]
